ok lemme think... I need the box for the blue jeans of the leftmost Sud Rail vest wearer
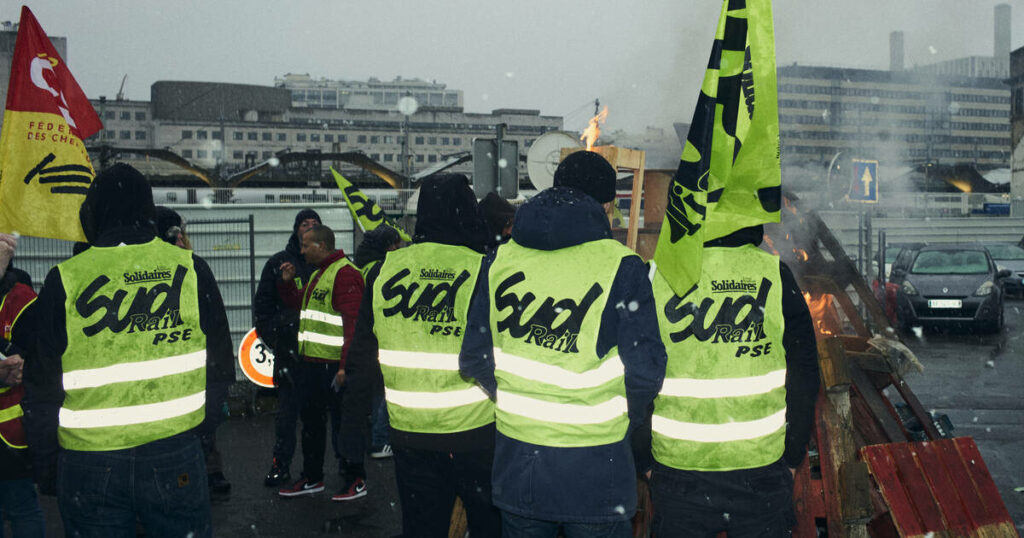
[57,432,213,538]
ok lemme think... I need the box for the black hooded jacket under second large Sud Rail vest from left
[342,174,495,451]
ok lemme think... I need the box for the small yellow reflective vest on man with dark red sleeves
[299,257,355,361]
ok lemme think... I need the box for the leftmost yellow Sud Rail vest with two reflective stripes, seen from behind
[57,239,206,451]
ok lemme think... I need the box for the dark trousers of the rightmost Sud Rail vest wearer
[650,460,796,538]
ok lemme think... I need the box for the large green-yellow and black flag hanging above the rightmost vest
[654,0,781,295]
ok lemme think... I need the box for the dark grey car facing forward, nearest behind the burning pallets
[893,245,1011,332]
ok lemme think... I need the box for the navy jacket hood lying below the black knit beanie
[512,187,611,250]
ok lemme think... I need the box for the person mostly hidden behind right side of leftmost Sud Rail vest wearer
[157,206,234,495]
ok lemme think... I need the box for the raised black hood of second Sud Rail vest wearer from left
[413,174,487,252]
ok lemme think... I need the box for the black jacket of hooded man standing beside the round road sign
[253,234,315,382]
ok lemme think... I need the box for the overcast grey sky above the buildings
[0,0,1024,130]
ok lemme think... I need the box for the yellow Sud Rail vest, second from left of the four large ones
[373,243,495,433]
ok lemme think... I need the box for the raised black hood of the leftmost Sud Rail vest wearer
[78,163,156,243]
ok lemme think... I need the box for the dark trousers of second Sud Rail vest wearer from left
[393,447,502,538]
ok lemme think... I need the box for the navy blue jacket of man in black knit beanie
[459,188,666,523]
